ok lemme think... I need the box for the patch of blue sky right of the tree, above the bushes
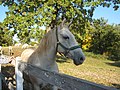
[93,6,120,24]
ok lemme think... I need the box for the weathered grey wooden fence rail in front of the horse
[19,63,117,90]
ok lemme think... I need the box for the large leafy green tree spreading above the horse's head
[1,0,120,43]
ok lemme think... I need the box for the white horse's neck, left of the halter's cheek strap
[37,30,57,61]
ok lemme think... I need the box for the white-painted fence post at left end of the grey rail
[15,57,23,90]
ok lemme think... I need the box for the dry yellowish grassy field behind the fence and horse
[1,47,120,88]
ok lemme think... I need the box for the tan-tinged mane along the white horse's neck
[36,30,54,54]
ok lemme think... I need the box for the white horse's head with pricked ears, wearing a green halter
[56,20,85,65]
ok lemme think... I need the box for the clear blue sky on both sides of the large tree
[0,5,120,24]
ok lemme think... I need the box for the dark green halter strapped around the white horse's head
[56,26,80,56]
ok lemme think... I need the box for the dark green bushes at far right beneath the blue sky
[90,19,120,60]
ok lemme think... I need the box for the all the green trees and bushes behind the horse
[0,0,120,60]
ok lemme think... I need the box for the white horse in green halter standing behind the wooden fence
[21,21,85,90]
